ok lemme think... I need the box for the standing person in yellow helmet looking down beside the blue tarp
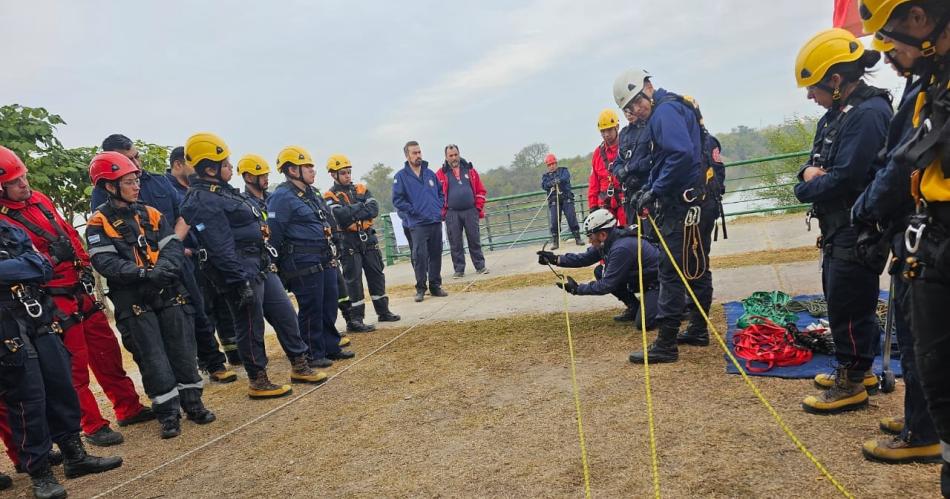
[795,28,893,414]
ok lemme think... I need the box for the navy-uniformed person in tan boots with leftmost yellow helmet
[181,133,327,399]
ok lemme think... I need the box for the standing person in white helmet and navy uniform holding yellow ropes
[614,70,718,364]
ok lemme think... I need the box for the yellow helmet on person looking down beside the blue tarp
[795,28,864,88]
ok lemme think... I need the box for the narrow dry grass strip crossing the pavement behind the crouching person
[387,246,818,297]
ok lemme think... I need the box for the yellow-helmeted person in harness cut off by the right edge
[856,0,950,497]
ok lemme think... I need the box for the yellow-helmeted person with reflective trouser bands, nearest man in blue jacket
[323,154,400,332]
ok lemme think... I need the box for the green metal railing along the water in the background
[380,151,809,265]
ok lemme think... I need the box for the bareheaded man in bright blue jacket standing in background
[393,140,449,302]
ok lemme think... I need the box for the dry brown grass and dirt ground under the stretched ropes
[11,306,939,498]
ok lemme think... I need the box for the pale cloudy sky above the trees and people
[0,0,901,188]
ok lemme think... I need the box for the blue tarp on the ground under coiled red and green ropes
[723,291,901,378]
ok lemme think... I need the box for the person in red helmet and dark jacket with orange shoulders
[86,152,215,438]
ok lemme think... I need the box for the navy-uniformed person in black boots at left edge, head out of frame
[0,194,122,498]
